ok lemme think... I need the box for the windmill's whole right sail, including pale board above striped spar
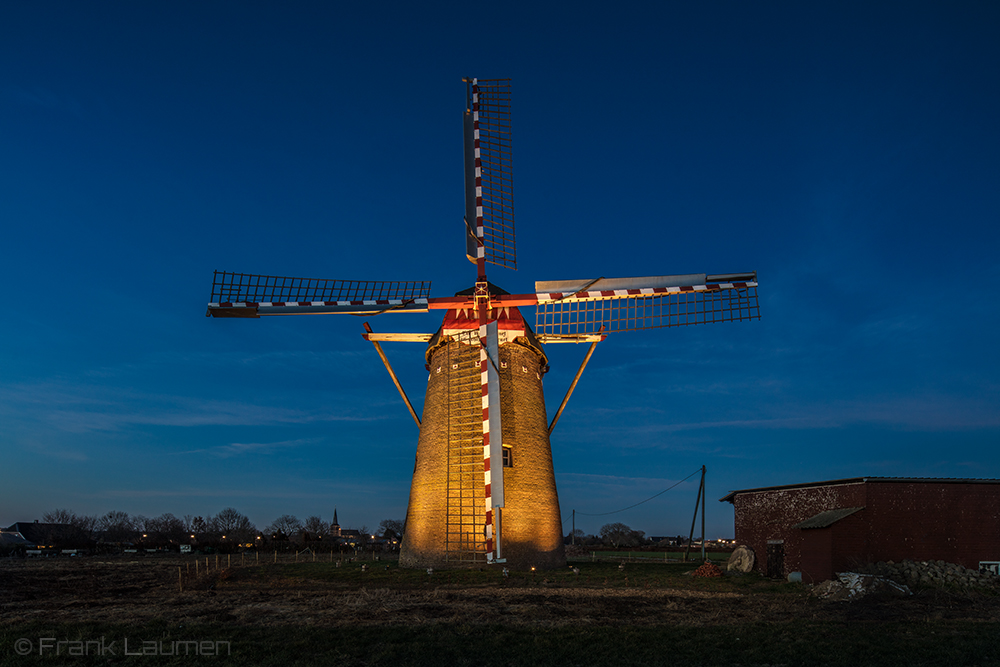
[535,273,760,335]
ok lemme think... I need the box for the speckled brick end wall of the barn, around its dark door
[733,482,865,575]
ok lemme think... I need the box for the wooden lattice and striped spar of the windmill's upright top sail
[471,79,517,270]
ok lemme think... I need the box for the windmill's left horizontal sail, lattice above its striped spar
[207,271,431,317]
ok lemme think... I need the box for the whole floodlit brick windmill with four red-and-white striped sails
[207,79,760,568]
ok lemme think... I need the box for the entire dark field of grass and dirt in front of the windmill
[0,558,1000,666]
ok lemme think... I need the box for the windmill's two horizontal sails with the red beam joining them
[208,272,760,336]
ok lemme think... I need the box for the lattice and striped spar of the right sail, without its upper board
[535,282,760,335]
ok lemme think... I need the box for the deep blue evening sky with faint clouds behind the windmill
[0,2,1000,537]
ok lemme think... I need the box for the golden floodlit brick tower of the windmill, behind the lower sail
[400,309,566,569]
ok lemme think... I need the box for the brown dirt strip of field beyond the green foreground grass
[0,557,1000,627]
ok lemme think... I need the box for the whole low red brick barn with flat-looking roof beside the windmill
[720,477,1000,583]
